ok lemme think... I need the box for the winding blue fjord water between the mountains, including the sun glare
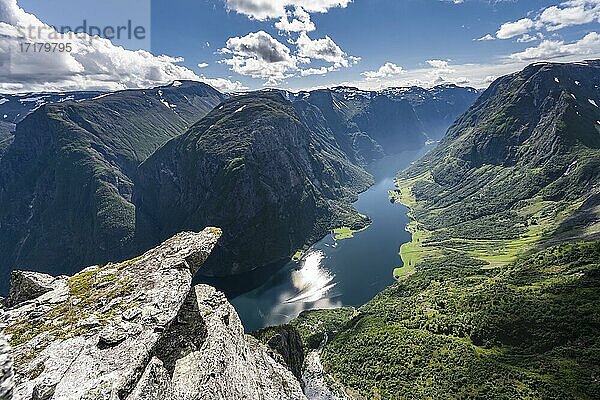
[201,150,426,331]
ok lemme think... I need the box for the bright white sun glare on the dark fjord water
[285,250,337,303]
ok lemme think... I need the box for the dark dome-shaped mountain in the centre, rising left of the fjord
[134,92,372,275]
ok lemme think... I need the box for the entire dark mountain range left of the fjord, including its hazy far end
[0,81,474,289]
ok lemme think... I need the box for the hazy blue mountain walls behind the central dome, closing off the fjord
[286,85,479,164]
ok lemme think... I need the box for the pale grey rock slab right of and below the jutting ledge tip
[173,285,305,400]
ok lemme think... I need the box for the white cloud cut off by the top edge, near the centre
[225,0,352,21]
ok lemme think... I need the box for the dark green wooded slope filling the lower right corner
[323,243,600,399]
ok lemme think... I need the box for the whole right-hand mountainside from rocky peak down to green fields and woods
[284,61,600,399]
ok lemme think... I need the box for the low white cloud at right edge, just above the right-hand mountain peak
[510,32,600,62]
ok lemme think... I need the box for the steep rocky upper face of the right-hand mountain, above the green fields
[404,61,600,236]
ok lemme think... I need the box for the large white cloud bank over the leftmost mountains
[0,0,243,92]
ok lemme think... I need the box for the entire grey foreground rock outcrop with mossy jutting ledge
[1,228,304,400]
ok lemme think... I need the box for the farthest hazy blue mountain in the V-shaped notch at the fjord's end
[382,85,480,140]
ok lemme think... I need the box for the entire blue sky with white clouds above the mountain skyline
[0,0,600,92]
